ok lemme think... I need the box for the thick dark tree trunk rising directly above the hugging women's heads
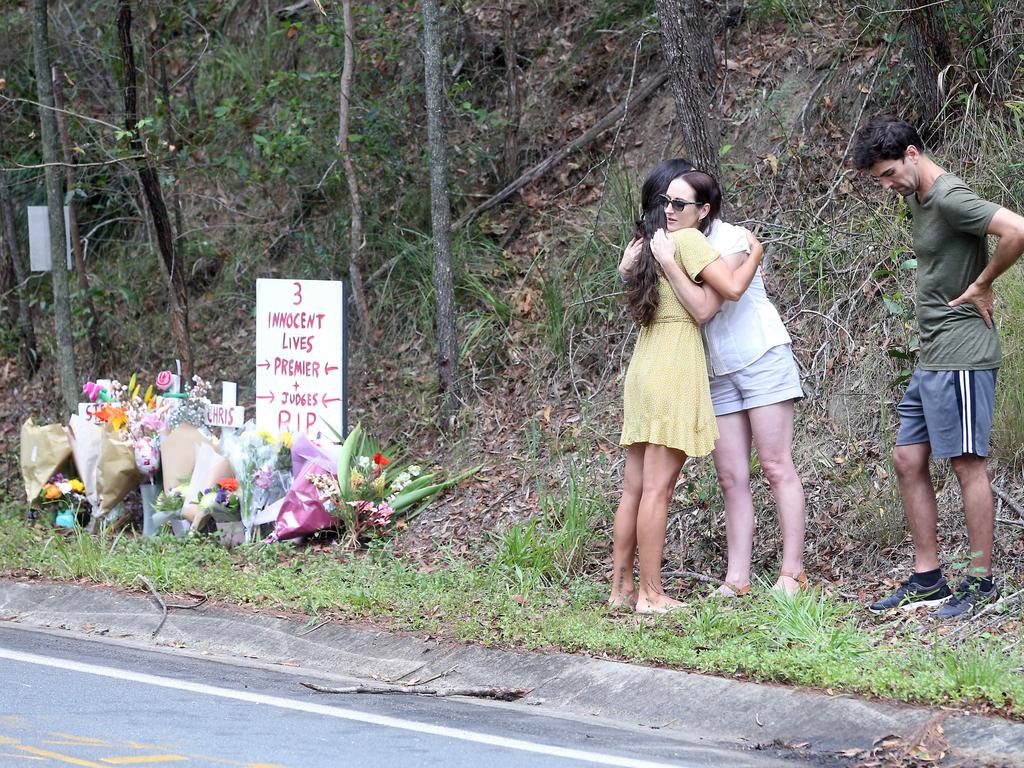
[654,0,721,178]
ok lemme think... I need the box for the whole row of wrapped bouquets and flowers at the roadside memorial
[20,371,477,548]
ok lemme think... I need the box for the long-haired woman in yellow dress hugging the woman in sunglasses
[608,160,760,613]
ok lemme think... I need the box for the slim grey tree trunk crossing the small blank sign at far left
[32,0,79,416]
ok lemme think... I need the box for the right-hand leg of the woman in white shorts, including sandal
[746,400,805,593]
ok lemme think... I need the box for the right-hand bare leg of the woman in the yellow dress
[636,443,686,613]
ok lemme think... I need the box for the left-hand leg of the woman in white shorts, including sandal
[712,411,754,595]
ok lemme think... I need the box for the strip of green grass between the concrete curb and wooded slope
[0,513,1024,718]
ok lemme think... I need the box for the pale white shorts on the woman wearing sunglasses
[710,344,804,416]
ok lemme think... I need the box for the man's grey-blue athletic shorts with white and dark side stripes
[896,368,998,459]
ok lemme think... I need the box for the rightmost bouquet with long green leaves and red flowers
[310,425,479,548]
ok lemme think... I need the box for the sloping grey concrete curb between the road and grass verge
[0,580,1024,767]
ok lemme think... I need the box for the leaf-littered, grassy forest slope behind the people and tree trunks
[0,0,1024,671]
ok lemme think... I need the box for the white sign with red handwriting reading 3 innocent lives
[256,280,345,439]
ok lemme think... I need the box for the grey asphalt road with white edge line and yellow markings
[0,626,806,768]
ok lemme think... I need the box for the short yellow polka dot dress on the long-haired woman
[620,229,718,456]
